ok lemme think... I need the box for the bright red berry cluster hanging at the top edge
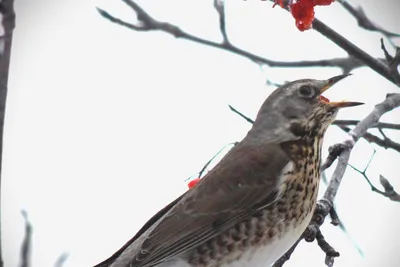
[274,0,335,31]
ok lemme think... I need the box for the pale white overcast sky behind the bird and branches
[1,0,400,267]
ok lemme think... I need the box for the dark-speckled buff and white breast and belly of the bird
[189,140,321,267]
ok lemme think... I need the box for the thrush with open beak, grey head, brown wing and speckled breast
[95,74,363,267]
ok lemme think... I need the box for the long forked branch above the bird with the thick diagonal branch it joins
[97,0,400,86]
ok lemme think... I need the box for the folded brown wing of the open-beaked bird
[130,143,289,267]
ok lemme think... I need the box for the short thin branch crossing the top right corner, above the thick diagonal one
[338,0,400,38]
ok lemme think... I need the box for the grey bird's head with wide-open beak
[252,75,363,143]
